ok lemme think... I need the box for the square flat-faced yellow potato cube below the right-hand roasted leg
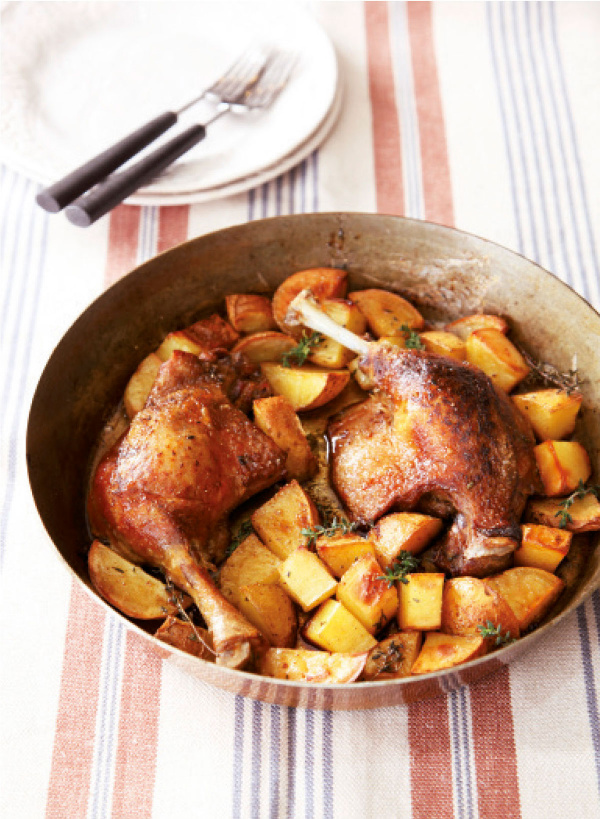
[398,572,444,631]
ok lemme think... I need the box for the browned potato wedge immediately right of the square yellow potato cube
[441,577,520,649]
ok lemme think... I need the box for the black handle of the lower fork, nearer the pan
[65,125,206,227]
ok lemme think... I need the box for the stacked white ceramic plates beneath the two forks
[0,2,340,204]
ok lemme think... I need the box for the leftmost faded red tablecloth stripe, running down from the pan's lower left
[46,583,105,819]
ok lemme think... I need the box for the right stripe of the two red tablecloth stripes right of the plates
[406,2,454,225]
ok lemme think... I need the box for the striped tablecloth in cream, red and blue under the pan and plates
[0,2,600,819]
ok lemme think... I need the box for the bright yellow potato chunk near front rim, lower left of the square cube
[303,599,377,654]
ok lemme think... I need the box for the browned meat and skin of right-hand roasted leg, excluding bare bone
[329,344,539,577]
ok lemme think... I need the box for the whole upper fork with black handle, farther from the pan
[36,46,274,213]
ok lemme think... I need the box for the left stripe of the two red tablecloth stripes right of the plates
[364,2,404,216]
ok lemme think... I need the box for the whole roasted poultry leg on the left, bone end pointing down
[88,351,285,662]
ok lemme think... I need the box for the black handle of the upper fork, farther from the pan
[36,111,177,213]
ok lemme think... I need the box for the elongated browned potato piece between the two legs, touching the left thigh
[253,395,318,482]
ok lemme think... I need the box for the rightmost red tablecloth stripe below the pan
[471,667,521,819]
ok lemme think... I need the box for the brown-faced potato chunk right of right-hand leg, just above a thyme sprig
[533,441,592,497]
